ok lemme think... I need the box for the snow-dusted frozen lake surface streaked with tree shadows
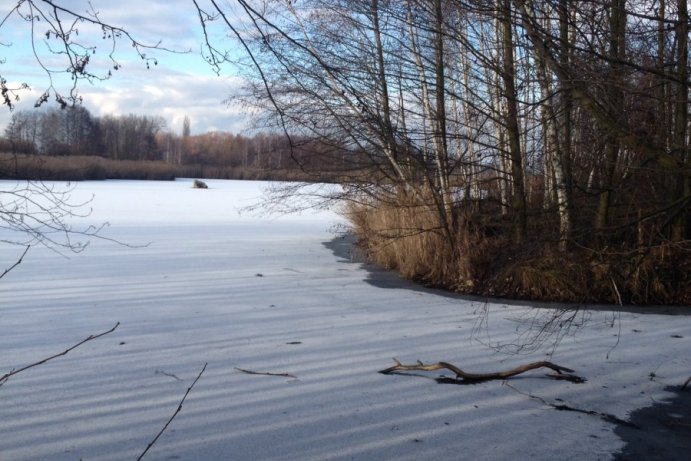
[0,180,691,461]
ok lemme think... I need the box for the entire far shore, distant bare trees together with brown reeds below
[0,106,344,180]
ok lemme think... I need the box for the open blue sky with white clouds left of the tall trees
[0,0,249,134]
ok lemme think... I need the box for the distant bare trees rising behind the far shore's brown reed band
[0,105,336,170]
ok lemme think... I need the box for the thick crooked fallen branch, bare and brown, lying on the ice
[379,359,585,382]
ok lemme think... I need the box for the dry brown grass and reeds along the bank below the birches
[346,197,691,305]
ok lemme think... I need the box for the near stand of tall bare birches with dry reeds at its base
[207,0,691,304]
